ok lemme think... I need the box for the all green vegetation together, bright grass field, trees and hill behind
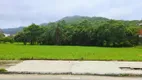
[0,16,142,61]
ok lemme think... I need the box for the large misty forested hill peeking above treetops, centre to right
[59,16,142,26]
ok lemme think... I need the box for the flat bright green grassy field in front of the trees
[0,44,142,61]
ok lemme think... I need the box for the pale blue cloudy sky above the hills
[0,0,142,29]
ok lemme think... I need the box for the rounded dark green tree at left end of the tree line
[14,24,43,45]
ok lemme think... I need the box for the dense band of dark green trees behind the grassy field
[15,17,140,47]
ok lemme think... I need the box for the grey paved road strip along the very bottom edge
[0,75,142,80]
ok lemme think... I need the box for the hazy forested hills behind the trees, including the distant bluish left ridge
[2,16,140,34]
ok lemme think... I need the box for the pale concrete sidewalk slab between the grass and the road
[7,60,142,75]
